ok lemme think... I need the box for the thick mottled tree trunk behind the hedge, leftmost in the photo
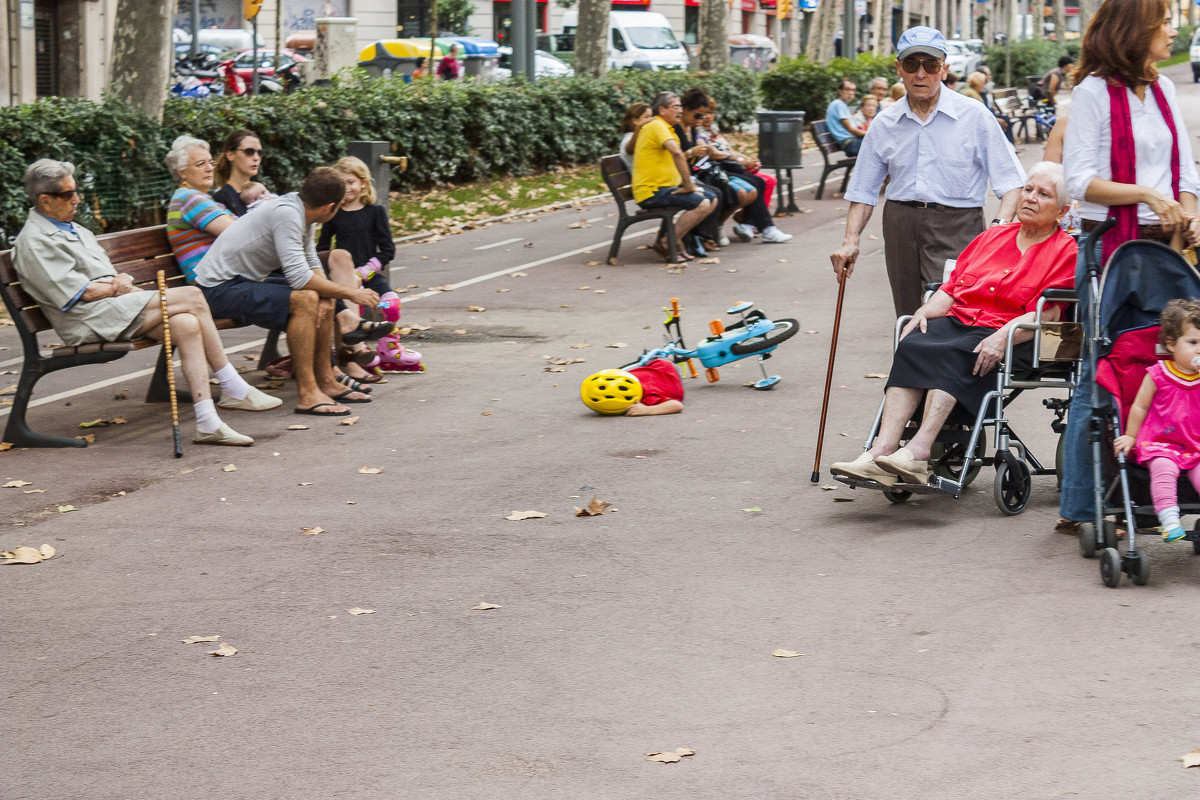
[108,0,175,120]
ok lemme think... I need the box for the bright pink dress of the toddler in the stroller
[1138,360,1200,470]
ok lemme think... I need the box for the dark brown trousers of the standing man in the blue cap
[883,200,984,317]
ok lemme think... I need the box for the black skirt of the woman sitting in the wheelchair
[888,317,1033,415]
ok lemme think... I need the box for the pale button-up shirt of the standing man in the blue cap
[846,86,1025,209]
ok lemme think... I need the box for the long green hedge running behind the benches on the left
[0,66,758,245]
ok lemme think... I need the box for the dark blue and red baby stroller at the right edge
[1079,223,1200,587]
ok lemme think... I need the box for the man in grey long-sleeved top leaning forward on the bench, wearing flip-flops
[196,167,379,416]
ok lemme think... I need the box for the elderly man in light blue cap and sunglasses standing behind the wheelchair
[829,25,1025,315]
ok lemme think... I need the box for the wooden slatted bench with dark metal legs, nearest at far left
[0,225,278,447]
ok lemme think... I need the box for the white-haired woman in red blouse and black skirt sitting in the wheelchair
[830,161,1078,486]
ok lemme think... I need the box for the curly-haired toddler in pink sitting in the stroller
[1112,300,1200,542]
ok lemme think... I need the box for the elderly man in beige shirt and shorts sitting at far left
[13,158,282,446]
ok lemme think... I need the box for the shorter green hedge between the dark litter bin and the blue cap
[761,53,896,121]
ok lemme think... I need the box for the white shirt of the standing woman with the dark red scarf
[1062,76,1200,225]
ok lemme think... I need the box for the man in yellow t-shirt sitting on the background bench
[631,91,716,264]
